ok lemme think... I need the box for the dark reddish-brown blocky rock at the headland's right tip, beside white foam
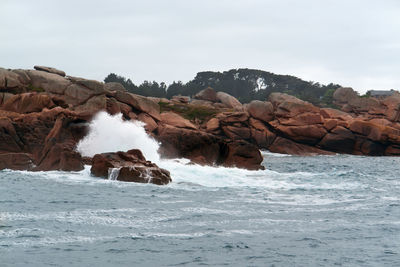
[223,140,264,170]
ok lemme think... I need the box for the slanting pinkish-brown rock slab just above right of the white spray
[115,91,161,121]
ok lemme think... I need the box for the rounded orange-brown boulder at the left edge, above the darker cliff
[2,93,55,113]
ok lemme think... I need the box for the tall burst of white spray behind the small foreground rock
[76,112,160,162]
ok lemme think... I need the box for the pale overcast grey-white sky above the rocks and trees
[0,0,400,93]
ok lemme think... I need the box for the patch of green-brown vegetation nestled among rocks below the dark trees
[158,102,217,123]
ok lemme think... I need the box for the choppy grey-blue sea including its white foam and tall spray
[0,114,400,266]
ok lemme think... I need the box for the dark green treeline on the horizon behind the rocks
[104,69,340,106]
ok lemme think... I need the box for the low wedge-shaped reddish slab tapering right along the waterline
[268,137,334,156]
